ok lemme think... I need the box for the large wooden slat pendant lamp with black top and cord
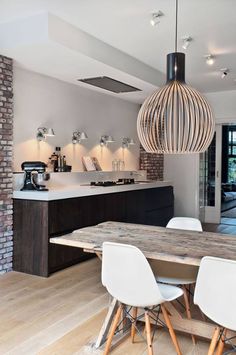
[137,0,215,154]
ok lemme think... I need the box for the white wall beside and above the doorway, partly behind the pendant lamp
[164,90,236,217]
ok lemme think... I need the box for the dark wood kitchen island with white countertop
[13,181,174,277]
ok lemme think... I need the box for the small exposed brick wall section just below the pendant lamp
[139,145,164,180]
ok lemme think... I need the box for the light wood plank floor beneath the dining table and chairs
[0,258,208,355]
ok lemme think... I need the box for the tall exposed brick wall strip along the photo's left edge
[0,55,13,274]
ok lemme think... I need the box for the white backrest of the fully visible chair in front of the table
[102,242,163,307]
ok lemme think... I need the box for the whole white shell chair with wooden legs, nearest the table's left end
[102,242,183,355]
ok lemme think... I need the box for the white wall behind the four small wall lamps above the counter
[14,68,139,171]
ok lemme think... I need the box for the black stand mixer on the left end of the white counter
[21,161,48,191]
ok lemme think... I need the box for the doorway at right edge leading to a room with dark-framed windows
[199,124,236,228]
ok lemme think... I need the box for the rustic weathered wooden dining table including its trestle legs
[50,222,236,348]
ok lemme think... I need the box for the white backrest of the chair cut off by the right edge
[194,256,236,331]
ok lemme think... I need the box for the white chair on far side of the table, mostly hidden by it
[150,217,202,343]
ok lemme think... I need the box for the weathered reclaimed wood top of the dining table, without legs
[50,222,236,265]
